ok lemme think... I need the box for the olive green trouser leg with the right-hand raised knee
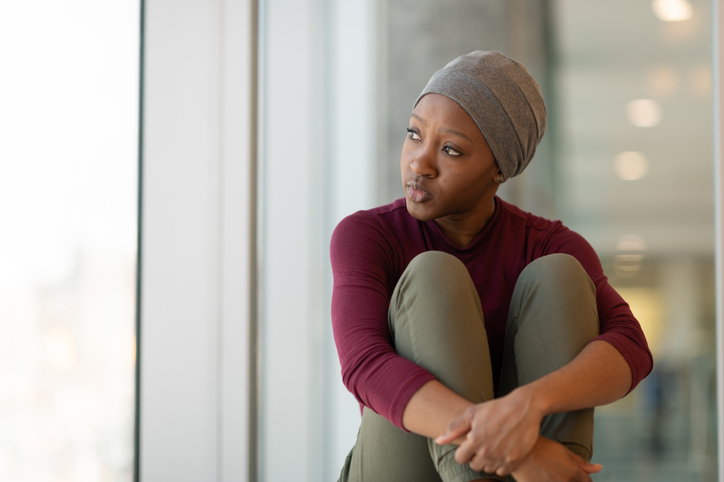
[499,254,599,460]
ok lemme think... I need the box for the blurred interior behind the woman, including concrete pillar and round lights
[378,0,717,481]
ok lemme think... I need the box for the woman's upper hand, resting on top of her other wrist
[435,387,544,475]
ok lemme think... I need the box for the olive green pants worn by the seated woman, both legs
[340,251,598,482]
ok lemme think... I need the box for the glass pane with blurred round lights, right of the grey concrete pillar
[551,0,717,481]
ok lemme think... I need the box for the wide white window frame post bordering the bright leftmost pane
[137,0,257,482]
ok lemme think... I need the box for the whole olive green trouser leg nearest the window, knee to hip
[341,251,499,482]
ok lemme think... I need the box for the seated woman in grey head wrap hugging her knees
[331,51,653,482]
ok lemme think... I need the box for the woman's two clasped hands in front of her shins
[435,387,602,482]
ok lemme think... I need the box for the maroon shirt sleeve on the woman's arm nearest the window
[330,211,435,430]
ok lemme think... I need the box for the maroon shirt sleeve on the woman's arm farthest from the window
[544,224,653,392]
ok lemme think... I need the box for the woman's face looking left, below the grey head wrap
[400,94,500,229]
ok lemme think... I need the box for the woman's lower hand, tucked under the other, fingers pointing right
[513,436,603,482]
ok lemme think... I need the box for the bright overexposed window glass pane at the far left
[0,0,140,482]
